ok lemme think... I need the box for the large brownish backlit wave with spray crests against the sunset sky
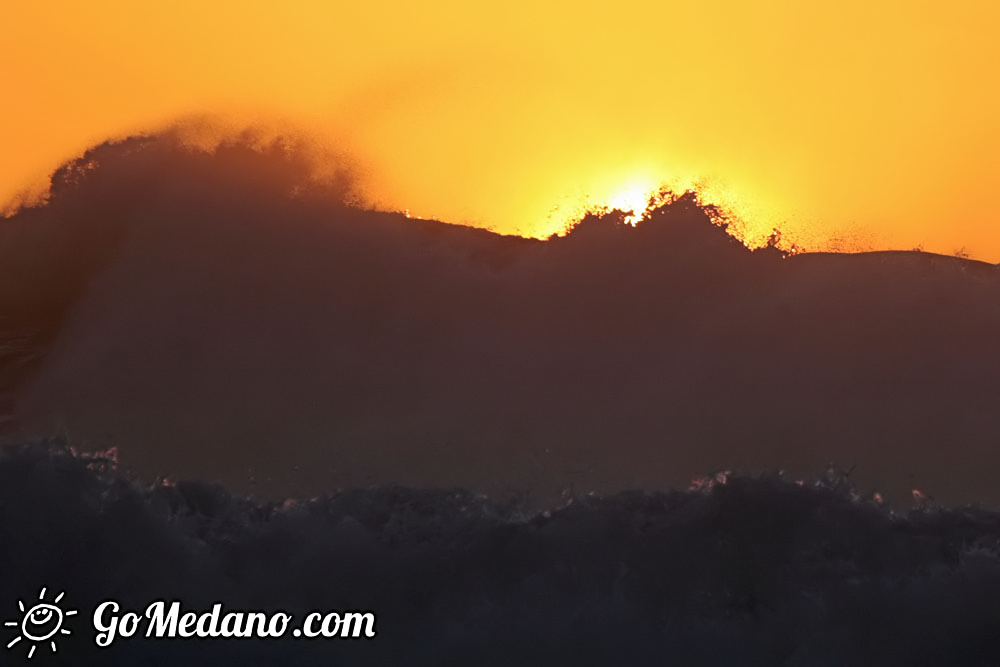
[0,130,1000,505]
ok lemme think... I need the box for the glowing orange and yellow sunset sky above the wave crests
[0,0,1000,262]
